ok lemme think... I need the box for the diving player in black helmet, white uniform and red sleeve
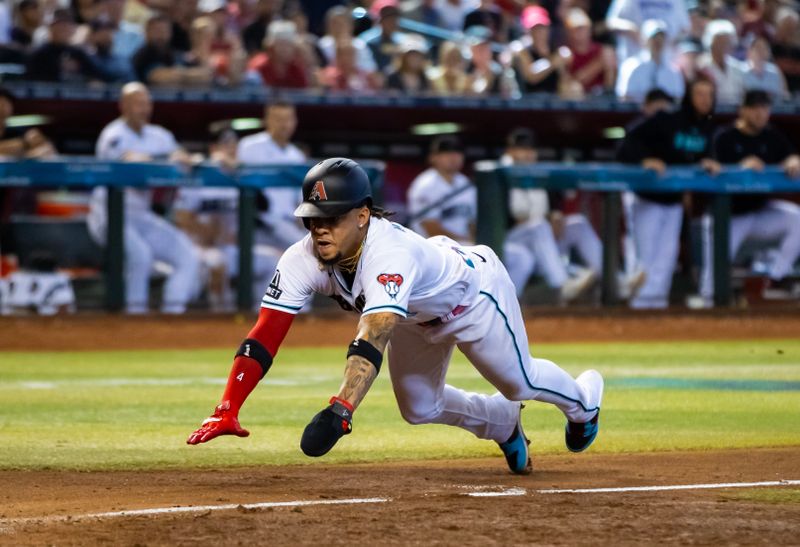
[187,158,603,474]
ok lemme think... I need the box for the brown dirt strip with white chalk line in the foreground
[0,448,800,545]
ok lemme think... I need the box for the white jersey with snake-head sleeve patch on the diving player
[261,218,481,323]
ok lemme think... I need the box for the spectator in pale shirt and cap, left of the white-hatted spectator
[616,19,685,102]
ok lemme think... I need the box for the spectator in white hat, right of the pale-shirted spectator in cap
[697,19,744,104]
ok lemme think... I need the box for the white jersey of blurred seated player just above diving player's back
[408,168,478,241]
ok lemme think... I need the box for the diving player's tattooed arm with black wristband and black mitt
[300,313,398,456]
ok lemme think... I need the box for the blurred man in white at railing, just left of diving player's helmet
[236,103,307,249]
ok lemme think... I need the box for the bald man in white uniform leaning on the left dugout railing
[87,82,200,313]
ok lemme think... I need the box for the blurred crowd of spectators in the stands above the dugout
[0,0,800,104]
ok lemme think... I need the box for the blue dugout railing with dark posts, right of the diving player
[475,161,800,307]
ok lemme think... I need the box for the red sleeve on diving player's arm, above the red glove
[222,308,294,414]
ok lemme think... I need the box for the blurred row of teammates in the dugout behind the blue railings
[0,76,800,314]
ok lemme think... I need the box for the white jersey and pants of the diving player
[262,218,602,448]
